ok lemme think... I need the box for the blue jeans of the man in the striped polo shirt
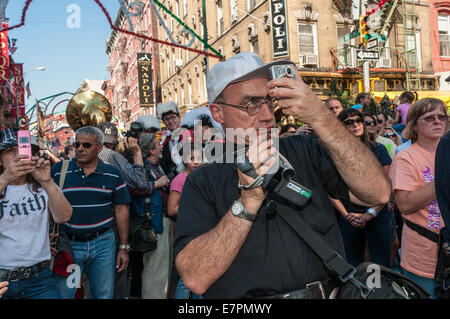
[55,228,116,299]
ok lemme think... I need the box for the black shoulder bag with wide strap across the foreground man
[277,203,430,299]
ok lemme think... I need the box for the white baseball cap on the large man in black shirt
[206,52,295,103]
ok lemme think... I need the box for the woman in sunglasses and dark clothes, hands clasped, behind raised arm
[331,109,392,267]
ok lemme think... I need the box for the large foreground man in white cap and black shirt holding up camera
[174,52,390,298]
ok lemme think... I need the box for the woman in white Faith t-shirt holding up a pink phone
[0,129,72,299]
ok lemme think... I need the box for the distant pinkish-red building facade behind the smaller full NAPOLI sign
[103,1,160,130]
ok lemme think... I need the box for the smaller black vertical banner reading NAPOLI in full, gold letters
[137,53,155,107]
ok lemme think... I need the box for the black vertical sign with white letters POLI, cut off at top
[270,0,289,58]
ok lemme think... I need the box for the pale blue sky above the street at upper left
[6,0,120,121]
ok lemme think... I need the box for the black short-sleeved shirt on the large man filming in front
[174,136,349,298]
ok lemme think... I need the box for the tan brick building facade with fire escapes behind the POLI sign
[158,0,439,112]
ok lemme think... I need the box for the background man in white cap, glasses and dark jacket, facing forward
[156,102,184,179]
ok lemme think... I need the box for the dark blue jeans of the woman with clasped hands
[339,208,392,268]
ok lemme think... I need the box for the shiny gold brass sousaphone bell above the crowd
[66,91,112,131]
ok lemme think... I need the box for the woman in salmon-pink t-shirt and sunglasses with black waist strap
[390,98,448,296]
